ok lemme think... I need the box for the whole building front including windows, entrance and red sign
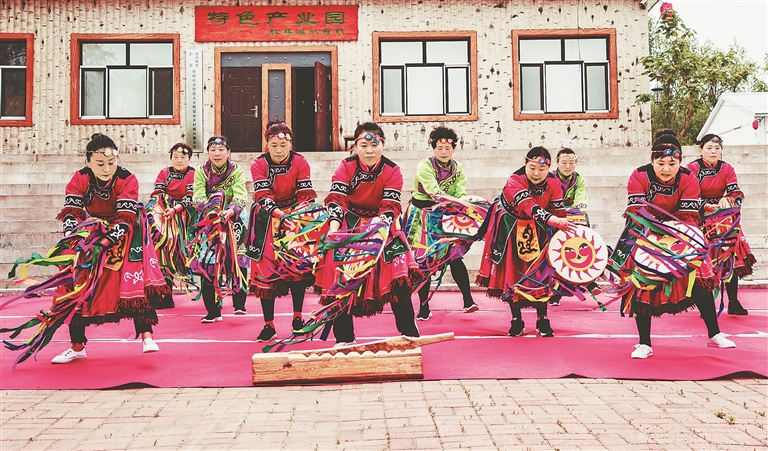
[0,0,651,154]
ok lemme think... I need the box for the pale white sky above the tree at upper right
[650,0,768,64]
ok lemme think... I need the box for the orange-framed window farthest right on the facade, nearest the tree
[512,29,618,120]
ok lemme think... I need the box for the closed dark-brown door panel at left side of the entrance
[221,67,262,152]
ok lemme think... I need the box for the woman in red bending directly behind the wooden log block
[317,122,419,346]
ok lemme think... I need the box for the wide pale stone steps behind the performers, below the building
[0,146,768,288]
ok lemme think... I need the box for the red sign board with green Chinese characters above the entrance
[195,5,357,42]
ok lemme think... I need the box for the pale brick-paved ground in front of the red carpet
[0,379,768,451]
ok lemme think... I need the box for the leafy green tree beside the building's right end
[636,10,768,145]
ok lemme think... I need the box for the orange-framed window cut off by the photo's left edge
[0,33,34,126]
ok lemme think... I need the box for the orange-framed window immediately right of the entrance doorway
[373,32,477,122]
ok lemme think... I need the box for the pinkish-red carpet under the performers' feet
[0,289,768,390]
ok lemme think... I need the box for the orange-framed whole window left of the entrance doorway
[72,35,179,124]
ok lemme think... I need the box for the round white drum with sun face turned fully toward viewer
[547,226,608,283]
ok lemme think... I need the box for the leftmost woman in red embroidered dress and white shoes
[52,133,168,363]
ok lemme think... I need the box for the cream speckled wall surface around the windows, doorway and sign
[0,0,651,154]
